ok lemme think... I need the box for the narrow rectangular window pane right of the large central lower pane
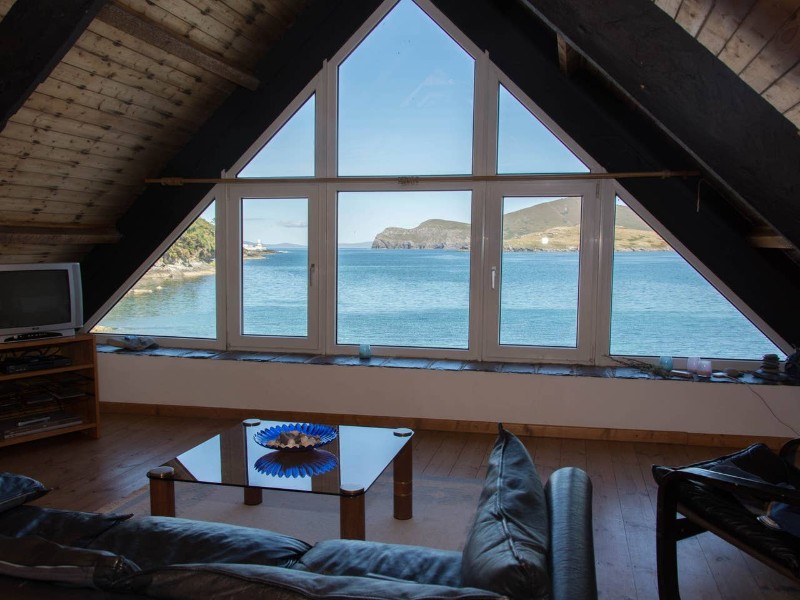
[500,197,581,348]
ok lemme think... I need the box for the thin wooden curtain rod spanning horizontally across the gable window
[144,171,700,186]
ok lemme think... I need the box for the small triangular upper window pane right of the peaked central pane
[497,85,589,174]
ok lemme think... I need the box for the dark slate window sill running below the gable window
[97,344,800,385]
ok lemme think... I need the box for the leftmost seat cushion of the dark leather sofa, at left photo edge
[0,506,132,548]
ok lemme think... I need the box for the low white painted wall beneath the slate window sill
[98,353,800,437]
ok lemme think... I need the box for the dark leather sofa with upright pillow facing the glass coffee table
[0,426,597,600]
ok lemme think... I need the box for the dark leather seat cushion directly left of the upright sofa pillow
[295,540,461,587]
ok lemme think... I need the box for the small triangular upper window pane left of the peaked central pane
[237,96,315,177]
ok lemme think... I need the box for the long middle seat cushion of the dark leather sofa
[89,517,311,569]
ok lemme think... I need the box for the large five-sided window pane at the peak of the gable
[338,0,475,176]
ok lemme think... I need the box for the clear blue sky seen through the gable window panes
[227,0,588,245]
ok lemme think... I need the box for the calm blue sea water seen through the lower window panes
[101,249,782,358]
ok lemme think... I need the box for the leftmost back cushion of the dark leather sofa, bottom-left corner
[0,536,139,597]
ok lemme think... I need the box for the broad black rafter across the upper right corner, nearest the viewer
[521,0,800,252]
